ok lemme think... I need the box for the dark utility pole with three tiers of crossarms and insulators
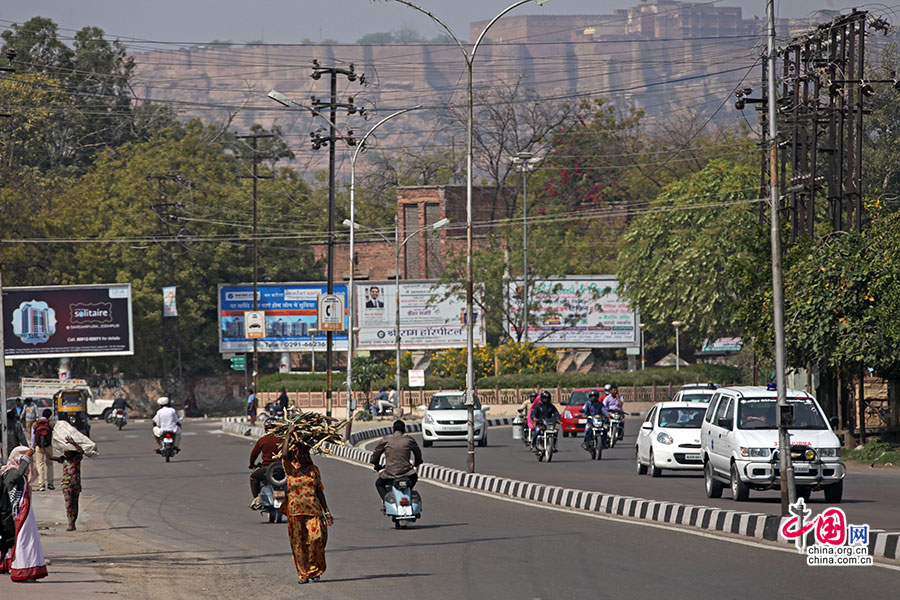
[310,60,366,417]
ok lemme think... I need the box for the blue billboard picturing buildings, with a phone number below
[218,283,349,352]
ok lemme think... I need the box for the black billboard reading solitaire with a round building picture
[3,283,134,360]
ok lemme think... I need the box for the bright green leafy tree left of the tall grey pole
[618,161,764,342]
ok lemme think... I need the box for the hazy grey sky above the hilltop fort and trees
[0,0,856,43]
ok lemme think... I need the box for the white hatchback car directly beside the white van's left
[635,402,706,477]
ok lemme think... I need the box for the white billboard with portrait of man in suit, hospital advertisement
[356,281,484,350]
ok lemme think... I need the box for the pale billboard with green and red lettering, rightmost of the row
[507,275,640,348]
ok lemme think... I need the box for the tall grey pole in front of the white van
[766,0,797,516]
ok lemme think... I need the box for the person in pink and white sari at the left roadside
[0,446,47,581]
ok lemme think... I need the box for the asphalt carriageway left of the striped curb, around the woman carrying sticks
[51,420,900,600]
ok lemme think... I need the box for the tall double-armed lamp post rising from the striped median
[394,0,550,473]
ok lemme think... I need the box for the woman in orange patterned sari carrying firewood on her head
[280,424,334,583]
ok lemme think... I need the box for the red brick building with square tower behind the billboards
[312,185,515,281]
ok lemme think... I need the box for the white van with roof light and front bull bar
[700,386,846,504]
